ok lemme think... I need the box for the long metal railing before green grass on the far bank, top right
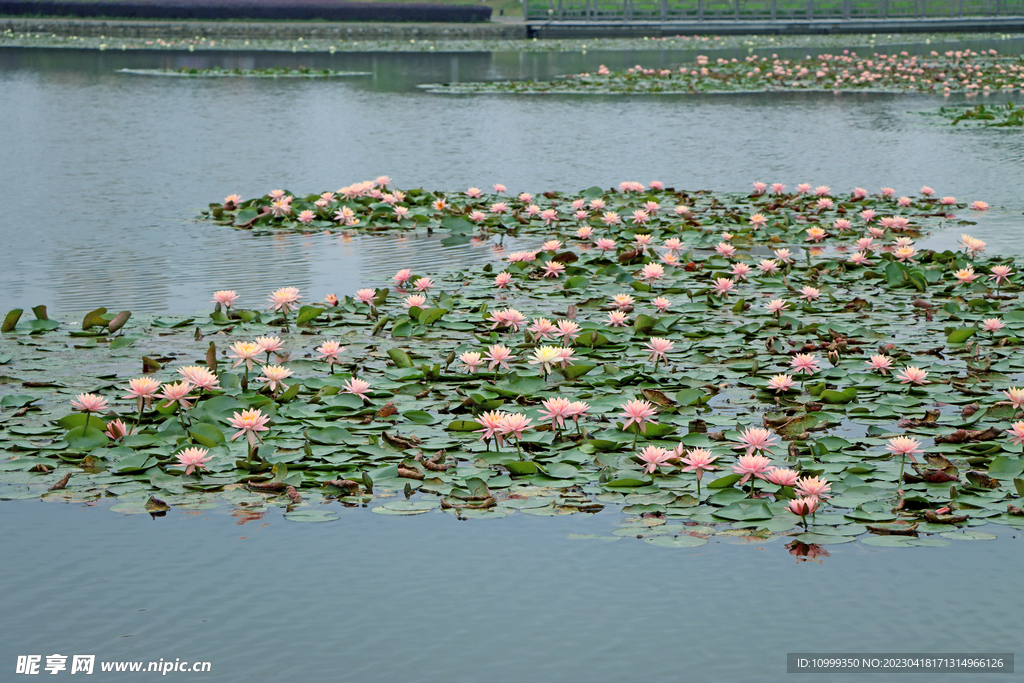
[522,0,1024,22]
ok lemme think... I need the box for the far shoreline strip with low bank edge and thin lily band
[0,17,1024,54]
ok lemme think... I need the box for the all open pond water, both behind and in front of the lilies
[0,47,1024,682]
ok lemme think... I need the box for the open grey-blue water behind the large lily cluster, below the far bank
[0,49,1024,312]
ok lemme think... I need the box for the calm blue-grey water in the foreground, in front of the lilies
[0,501,1024,683]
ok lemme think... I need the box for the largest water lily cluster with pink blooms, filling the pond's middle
[0,178,1024,557]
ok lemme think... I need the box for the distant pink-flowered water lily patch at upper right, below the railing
[421,50,1024,95]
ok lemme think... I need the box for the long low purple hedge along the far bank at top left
[0,0,490,23]
